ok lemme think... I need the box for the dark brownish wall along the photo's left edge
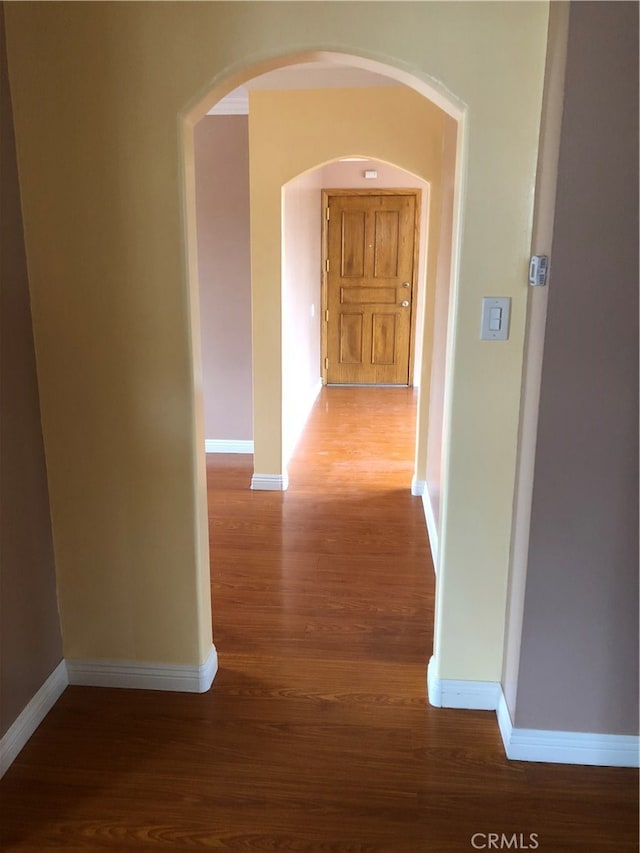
[0,4,62,735]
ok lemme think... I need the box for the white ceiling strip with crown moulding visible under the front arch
[208,60,402,115]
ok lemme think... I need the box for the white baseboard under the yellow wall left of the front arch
[67,645,218,693]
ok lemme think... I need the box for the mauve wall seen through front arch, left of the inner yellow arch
[193,116,253,441]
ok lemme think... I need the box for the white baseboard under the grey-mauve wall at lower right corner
[497,688,640,767]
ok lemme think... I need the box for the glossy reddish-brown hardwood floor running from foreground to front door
[0,388,638,853]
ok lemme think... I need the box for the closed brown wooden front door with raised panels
[325,190,417,385]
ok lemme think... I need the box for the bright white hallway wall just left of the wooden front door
[282,169,322,464]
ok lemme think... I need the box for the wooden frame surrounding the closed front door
[320,187,422,388]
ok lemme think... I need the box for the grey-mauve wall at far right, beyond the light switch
[514,2,638,734]
